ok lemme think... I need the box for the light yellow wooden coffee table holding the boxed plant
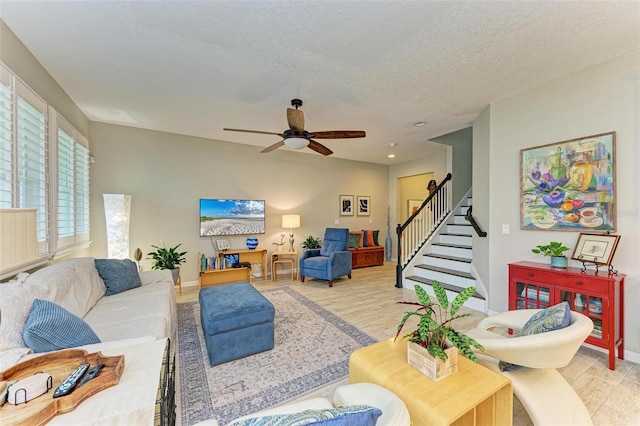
[349,339,513,426]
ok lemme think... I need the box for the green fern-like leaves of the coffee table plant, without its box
[394,281,484,362]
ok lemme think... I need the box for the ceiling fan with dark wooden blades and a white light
[223,99,366,155]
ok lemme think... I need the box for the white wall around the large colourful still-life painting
[482,53,640,361]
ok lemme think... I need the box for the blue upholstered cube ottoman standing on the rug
[198,282,275,366]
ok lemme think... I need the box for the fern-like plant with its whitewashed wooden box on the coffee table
[395,281,484,381]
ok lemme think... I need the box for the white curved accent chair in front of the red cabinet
[466,309,593,426]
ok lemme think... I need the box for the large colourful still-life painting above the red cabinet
[520,132,616,232]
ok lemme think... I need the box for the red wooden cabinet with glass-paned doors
[509,262,625,370]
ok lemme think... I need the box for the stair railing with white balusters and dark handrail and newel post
[396,173,452,288]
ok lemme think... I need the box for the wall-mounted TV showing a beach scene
[200,198,264,237]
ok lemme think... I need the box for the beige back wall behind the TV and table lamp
[91,123,389,281]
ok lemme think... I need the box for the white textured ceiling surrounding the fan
[0,0,640,164]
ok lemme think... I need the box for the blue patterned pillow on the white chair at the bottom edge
[227,405,382,426]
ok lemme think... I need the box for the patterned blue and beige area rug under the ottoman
[178,287,376,426]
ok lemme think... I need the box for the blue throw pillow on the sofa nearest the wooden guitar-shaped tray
[22,299,100,353]
